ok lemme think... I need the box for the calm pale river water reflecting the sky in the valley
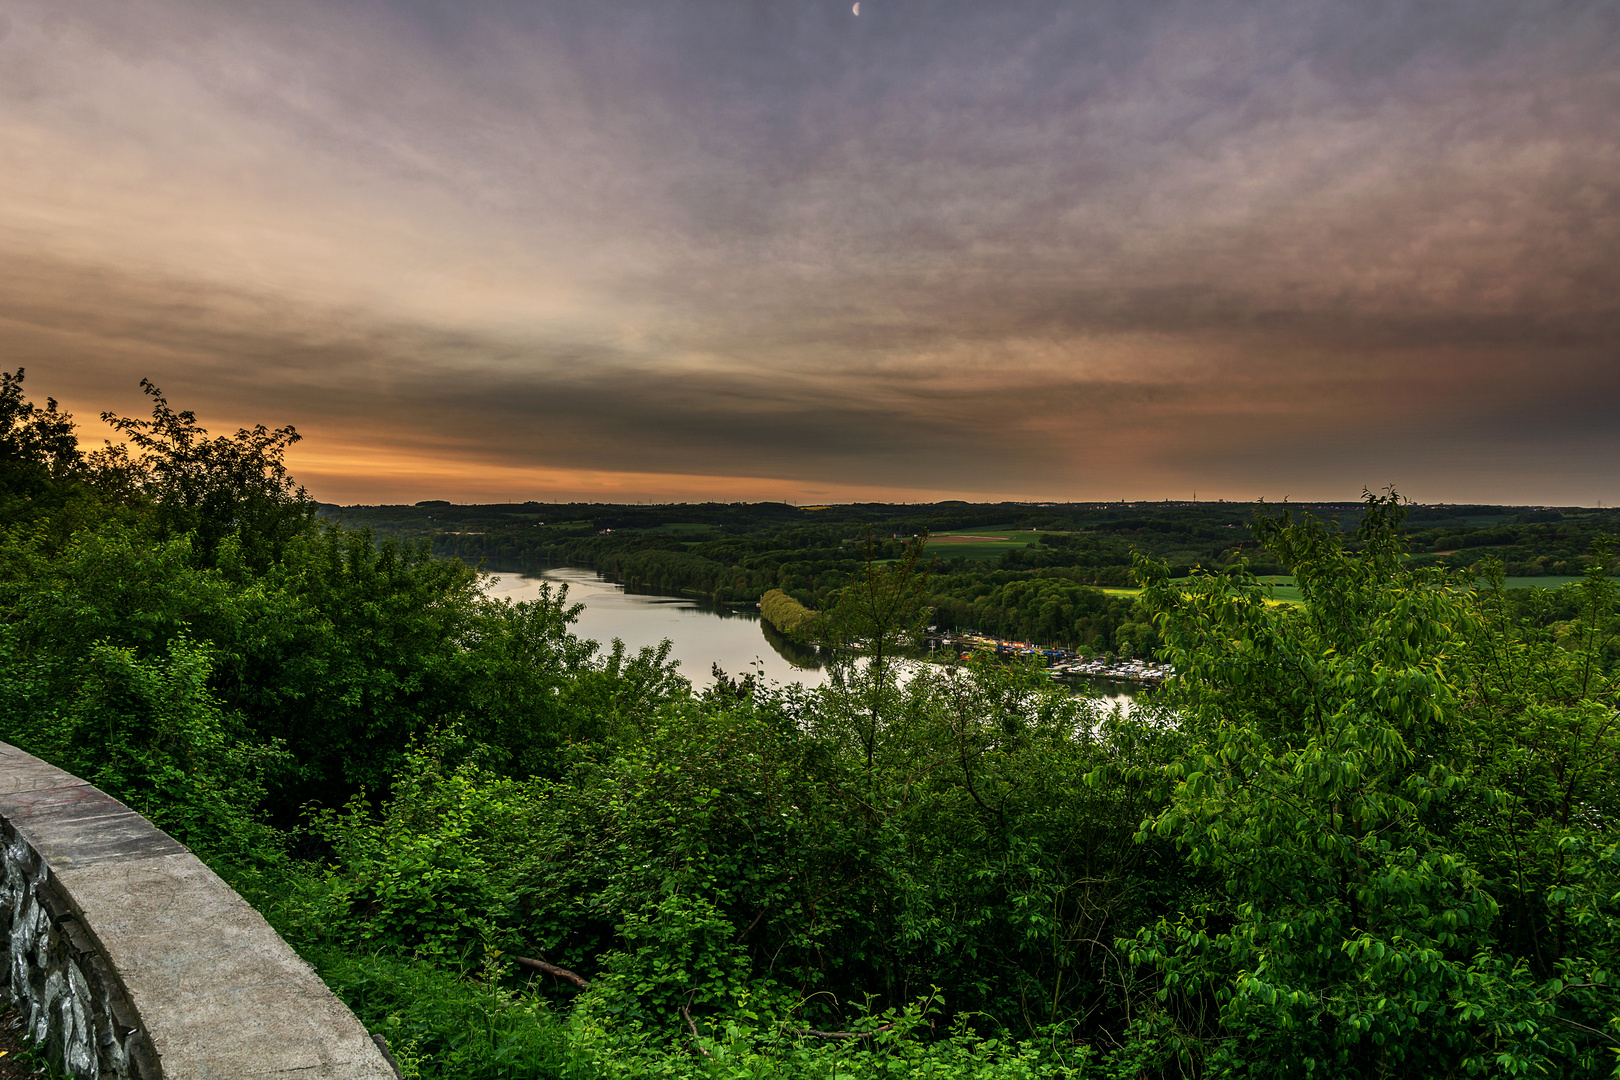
[489,567,1134,708]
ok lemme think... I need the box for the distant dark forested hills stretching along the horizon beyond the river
[319,500,1620,599]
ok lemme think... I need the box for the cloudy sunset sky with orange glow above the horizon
[0,0,1620,505]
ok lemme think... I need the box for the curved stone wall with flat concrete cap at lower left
[0,743,397,1080]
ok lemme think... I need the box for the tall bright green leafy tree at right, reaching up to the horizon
[1129,494,1620,1077]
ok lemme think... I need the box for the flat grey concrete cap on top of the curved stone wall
[0,743,397,1080]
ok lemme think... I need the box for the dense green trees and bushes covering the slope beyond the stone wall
[9,372,1620,1080]
